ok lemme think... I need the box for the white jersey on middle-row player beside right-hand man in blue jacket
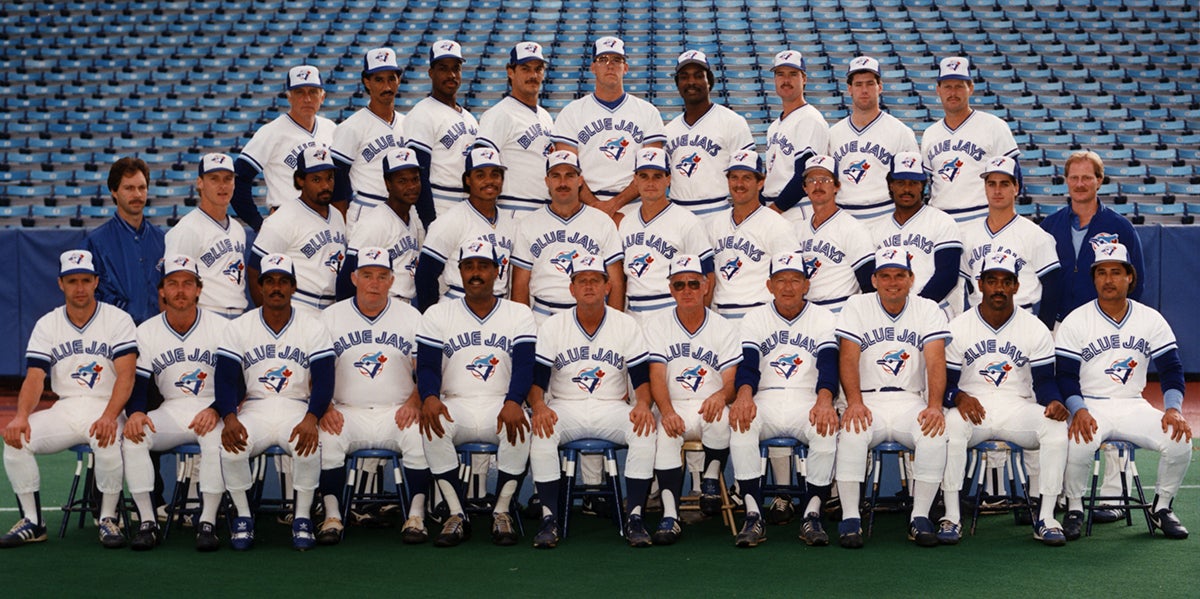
[959,215,1060,309]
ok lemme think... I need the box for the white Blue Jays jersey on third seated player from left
[217,305,334,403]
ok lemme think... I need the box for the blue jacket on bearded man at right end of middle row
[1042,204,1146,322]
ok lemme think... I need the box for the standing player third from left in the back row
[404,40,479,228]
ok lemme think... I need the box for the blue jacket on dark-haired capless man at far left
[84,216,167,324]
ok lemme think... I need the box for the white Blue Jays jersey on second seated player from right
[946,309,1055,403]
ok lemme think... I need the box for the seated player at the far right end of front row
[1055,244,1192,540]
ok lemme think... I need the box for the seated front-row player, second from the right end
[937,253,1067,546]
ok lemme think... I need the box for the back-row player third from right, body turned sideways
[762,50,836,223]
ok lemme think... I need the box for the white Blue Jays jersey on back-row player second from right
[829,112,919,221]
